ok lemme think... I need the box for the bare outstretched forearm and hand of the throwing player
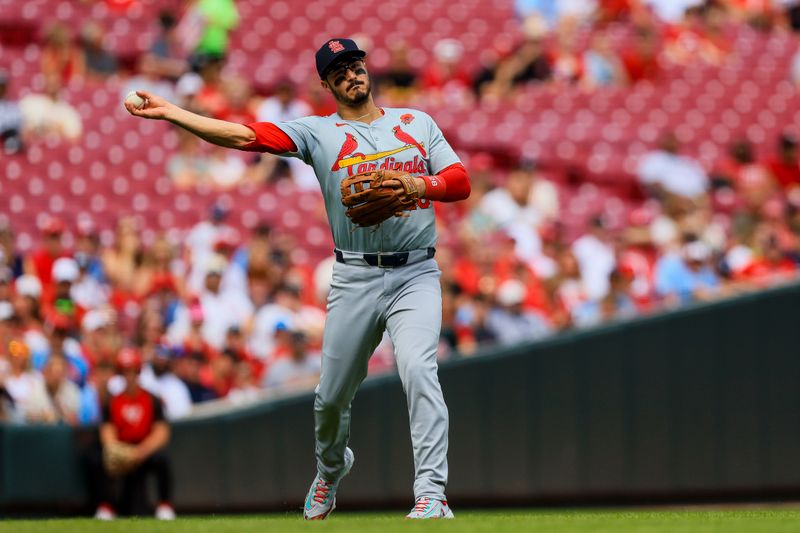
[125,91,256,149]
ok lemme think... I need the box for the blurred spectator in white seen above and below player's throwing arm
[256,80,319,189]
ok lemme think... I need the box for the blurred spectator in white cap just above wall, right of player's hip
[486,279,552,346]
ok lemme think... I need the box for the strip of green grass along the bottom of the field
[0,509,800,533]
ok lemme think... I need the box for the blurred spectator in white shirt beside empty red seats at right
[637,134,709,200]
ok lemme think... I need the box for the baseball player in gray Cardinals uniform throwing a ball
[125,39,470,520]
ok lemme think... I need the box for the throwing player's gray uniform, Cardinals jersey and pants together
[277,108,459,499]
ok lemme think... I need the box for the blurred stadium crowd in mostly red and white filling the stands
[0,0,800,424]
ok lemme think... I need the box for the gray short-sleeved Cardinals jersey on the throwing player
[277,107,459,252]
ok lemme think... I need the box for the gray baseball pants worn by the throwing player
[314,254,448,499]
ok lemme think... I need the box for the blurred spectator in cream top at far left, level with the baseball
[19,74,83,141]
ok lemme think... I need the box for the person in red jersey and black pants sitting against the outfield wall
[90,348,175,519]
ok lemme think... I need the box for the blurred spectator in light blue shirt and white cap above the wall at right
[655,240,720,305]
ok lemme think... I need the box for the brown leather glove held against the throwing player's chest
[341,170,420,228]
